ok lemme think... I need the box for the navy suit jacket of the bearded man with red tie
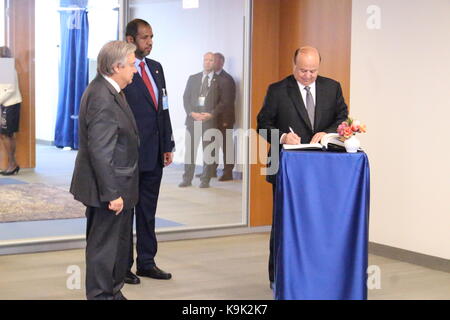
[123,58,175,171]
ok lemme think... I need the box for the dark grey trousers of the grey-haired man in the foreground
[86,207,131,300]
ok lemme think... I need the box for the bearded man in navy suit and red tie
[124,19,175,284]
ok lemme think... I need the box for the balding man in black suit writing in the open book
[258,47,348,283]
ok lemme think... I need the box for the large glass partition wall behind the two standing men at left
[0,0,250,247]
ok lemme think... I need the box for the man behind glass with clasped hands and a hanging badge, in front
[178,52,219,188]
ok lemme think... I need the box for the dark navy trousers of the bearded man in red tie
[128,163,163,270]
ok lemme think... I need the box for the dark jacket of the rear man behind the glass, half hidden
[216,69,236,127]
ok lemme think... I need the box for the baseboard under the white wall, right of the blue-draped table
[369,242,450,273]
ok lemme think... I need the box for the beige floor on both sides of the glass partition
[0,146,450,300]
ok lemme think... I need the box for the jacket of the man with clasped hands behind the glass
[183,72,219,127]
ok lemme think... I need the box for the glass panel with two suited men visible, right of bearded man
[129,0,250,230]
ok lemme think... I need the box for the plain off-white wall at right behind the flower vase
[350,0,450,259]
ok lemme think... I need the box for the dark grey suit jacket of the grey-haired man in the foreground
[70,75,139,209]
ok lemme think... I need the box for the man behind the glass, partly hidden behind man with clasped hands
[214,52,236,181]
